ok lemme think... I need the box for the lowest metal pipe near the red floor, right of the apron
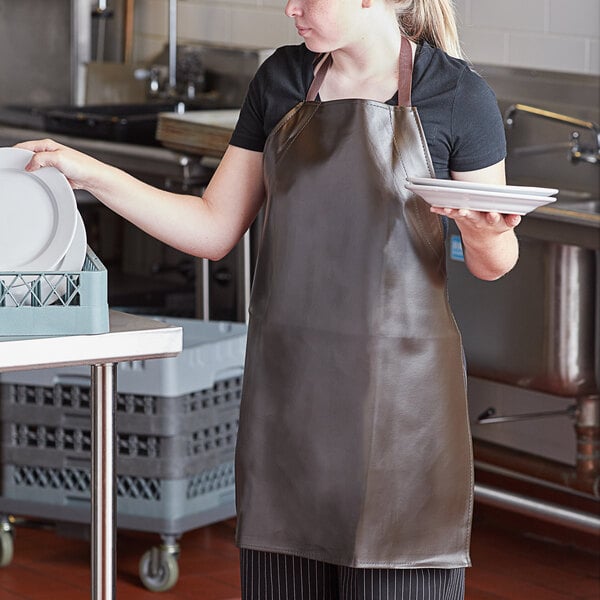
[475,484,600,535]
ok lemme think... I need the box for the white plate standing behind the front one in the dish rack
[0,212,87,306]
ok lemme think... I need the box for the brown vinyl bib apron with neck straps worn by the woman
[236,40,472,568]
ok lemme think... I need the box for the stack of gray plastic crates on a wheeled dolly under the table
[0,318,246,535]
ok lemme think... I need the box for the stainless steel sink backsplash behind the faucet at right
[475,65,600,197]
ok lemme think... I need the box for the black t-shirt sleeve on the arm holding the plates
[450,68,506,171]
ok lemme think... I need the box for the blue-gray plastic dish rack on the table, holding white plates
[0,247,109,337]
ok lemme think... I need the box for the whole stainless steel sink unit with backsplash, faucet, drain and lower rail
[448,67,600,520]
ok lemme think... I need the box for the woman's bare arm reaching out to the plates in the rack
[18,140,264,260]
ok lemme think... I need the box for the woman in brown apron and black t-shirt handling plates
[22,0,519,599]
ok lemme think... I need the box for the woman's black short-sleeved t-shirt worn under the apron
[230,43,506,179]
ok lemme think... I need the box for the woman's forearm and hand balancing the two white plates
[431,161,521,281]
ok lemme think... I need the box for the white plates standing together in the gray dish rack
[0,148,87,306]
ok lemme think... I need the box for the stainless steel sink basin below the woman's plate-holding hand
[448,220,600,397]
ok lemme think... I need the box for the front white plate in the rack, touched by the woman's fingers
[0,148,77,271]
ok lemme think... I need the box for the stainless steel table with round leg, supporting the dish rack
[0,311,183,600]
